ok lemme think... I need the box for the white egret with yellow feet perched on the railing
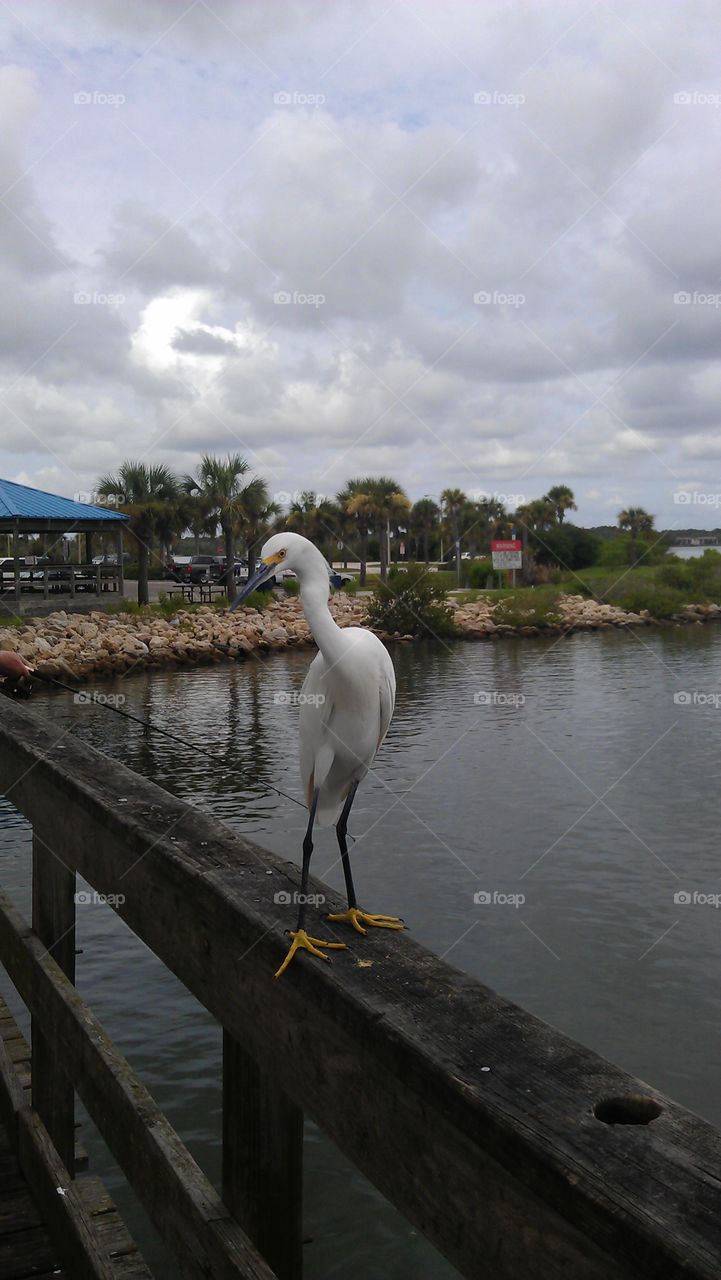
[232,532,403,978]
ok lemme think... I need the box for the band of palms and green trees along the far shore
[97,453,653,603]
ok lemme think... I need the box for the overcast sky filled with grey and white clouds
[0,0,721,527]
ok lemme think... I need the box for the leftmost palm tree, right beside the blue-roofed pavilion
[97,458,183,604]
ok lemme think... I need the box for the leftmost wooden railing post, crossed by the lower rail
[32,828,76,1176]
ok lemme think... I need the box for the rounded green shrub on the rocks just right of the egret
[368,564,456,636]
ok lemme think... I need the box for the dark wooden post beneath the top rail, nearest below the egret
[223,1030,304,1280]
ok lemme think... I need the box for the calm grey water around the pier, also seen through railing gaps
[0,627,721,1280]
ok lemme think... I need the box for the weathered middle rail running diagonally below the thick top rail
[0,895,274,1280]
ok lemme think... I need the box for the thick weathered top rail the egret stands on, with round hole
[0,703,721,1280]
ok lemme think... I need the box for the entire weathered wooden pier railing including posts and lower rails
[0,700,721,1280]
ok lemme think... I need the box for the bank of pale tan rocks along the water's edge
[0,594,721,682]
